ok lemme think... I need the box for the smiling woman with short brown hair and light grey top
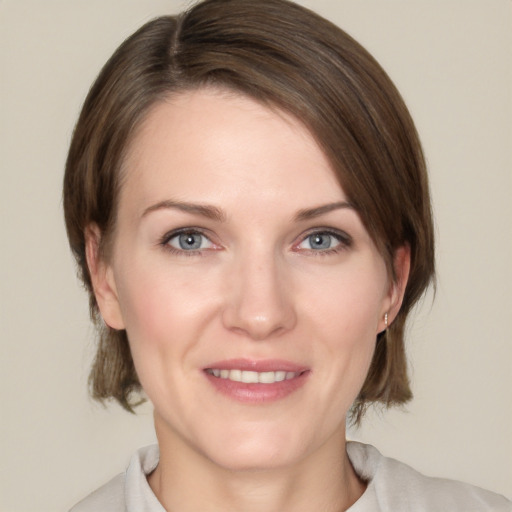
[64,0,510,511]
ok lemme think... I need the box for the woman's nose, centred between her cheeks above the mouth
[222,249,297,340]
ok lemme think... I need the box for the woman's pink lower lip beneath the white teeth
[204,371,309,404]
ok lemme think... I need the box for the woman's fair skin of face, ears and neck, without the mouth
[87,89,409,512]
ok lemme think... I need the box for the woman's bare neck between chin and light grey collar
[148,424,365,512]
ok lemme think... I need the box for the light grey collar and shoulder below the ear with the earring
[347,442,512,512]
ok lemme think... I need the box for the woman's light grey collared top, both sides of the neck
[71,442,512,512]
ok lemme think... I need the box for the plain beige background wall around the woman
[0,0,512,512]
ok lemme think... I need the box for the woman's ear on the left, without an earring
[85,224,125,330]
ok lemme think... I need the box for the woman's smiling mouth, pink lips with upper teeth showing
[203,359,311,404]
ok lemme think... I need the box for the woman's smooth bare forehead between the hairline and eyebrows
[121,89,344,215]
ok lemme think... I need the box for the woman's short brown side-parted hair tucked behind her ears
[64,0,434,421]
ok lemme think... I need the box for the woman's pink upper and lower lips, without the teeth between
[203,359,311,404]
